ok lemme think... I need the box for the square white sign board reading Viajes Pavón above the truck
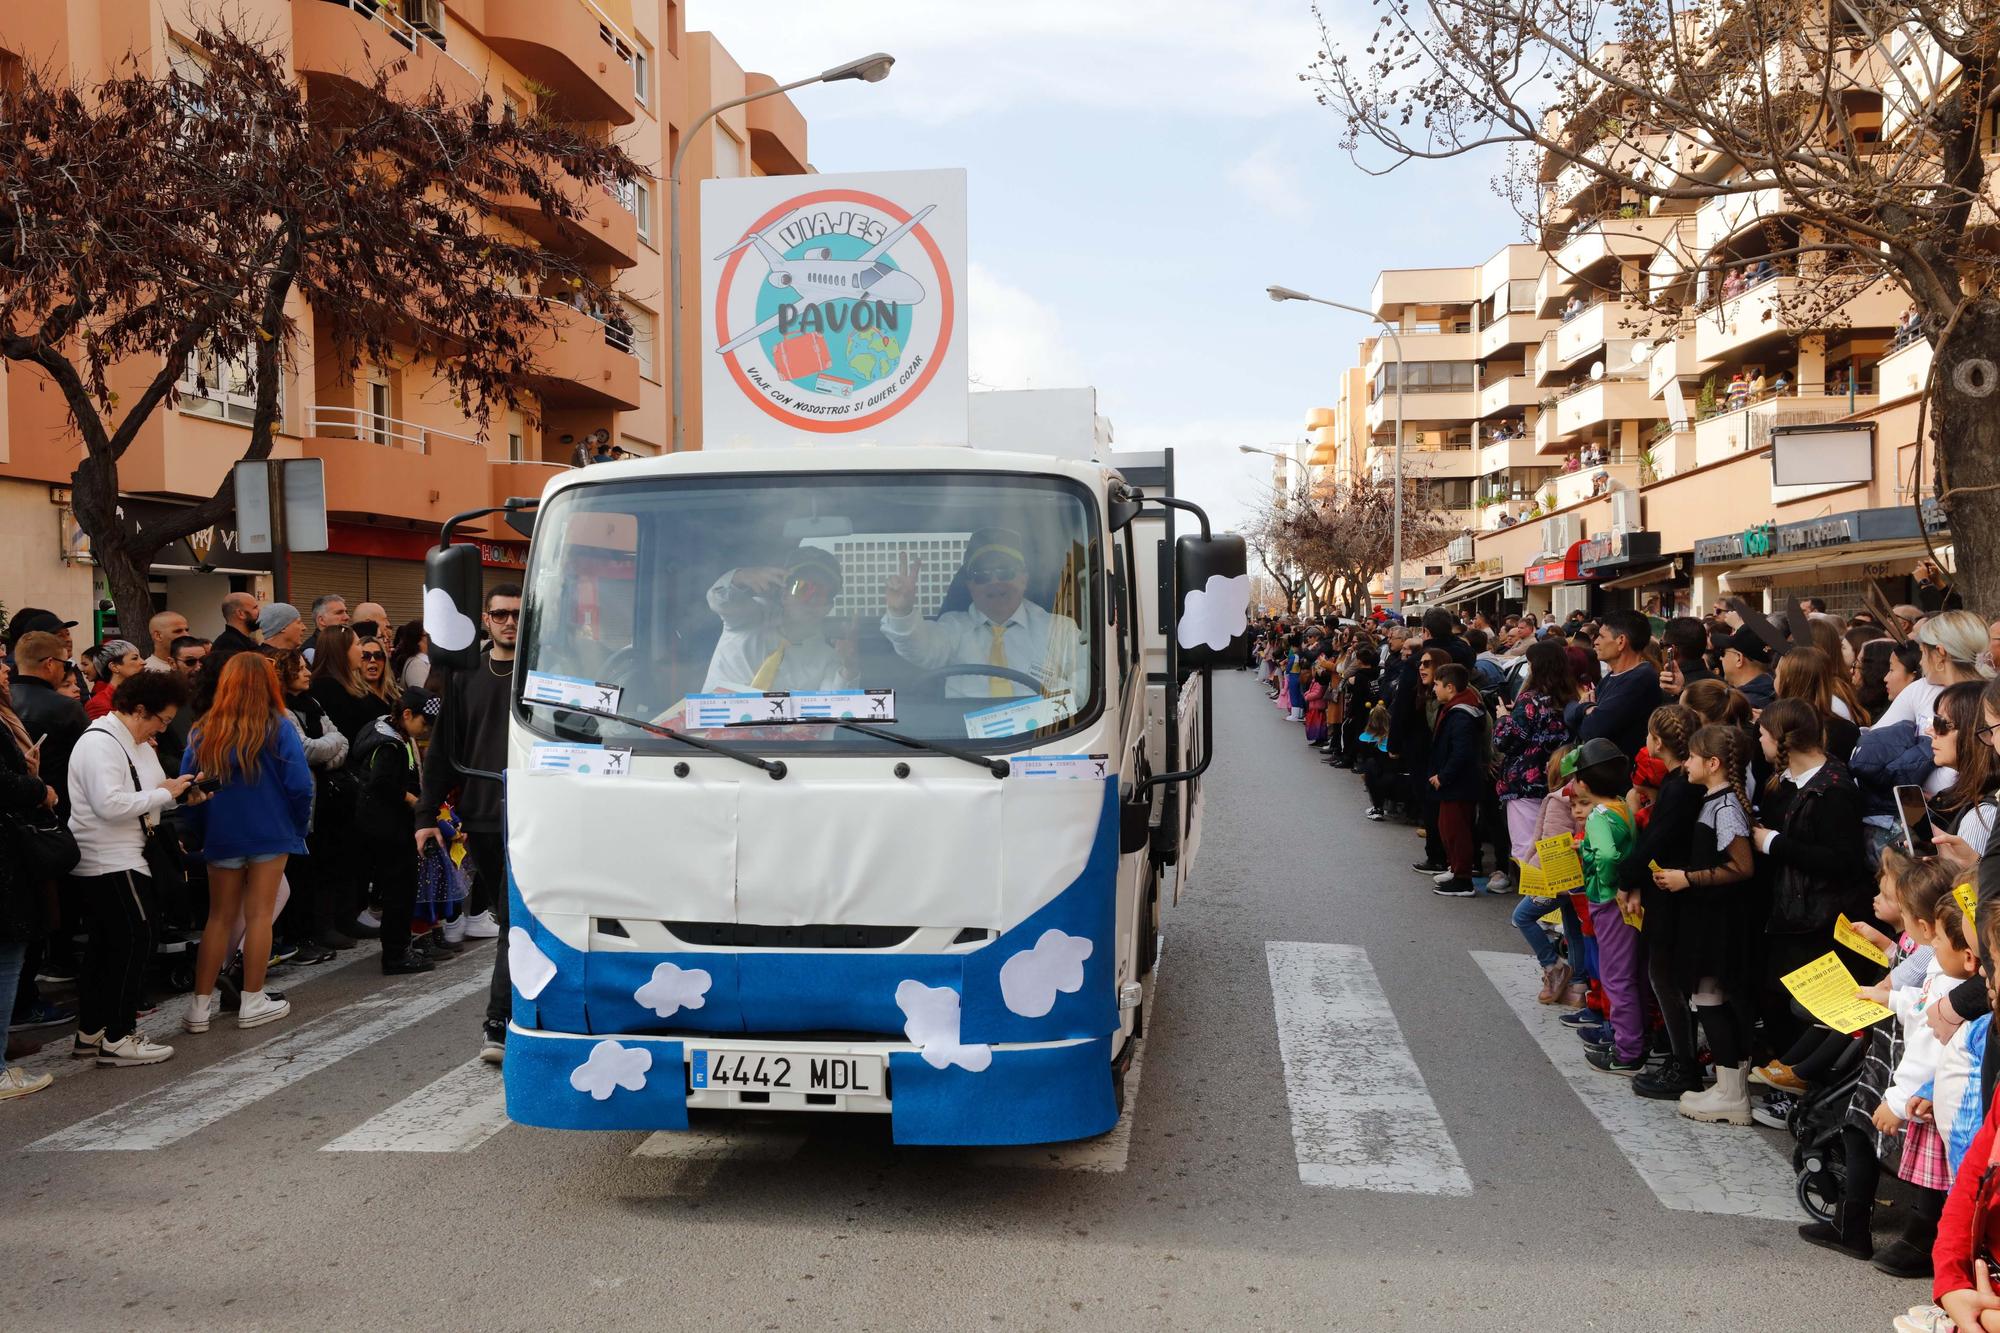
[700,170,966,448]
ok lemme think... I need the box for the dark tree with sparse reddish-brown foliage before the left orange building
[0,28,640,626]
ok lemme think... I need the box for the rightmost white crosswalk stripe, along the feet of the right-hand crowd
[1472,951,1800,1223]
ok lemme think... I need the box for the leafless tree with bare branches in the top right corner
[1306,0,2000,606]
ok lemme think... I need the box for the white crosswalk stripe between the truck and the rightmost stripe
[1264,941,1472,1195]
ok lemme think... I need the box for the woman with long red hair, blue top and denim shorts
[180,652,312,1033]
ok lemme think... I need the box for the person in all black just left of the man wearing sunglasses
[348,689,442,977]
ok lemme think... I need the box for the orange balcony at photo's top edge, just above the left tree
[292,0,484,108]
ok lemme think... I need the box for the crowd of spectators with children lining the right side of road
[1252,584,2000,1333]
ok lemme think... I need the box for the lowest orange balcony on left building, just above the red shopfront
[302,406,492,524]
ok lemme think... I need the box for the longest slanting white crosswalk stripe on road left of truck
[28,973,488,1153]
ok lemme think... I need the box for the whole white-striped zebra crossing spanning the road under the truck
[11,928,1832,1221]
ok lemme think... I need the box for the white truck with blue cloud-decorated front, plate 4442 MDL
[426,390,1248,1145]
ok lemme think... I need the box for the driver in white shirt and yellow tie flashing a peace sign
[882,528,1090,709]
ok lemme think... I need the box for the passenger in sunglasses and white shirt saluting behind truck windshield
[702,546,858,695]
